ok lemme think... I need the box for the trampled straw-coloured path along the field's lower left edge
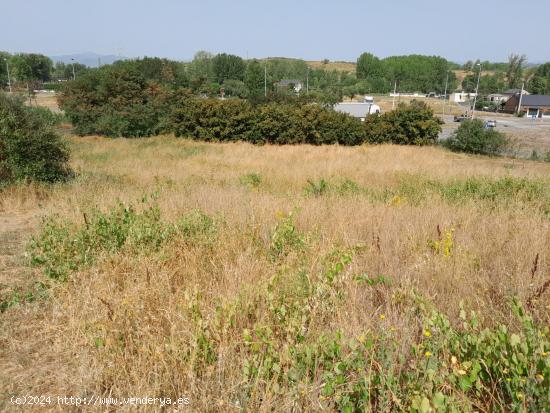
[0,210,82,412]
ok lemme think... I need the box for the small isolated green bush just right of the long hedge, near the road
[443,119,509,155]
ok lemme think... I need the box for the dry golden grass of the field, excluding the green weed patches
[0,137,550,412]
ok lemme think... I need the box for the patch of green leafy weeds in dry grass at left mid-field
[28,198,215,281]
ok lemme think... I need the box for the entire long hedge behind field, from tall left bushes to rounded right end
[59,66,441,145]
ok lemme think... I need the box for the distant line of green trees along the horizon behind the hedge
[0,51,550,103]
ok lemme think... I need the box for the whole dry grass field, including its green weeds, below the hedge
[0,136,550,412]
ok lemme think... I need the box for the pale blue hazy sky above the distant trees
[0,0,550,63]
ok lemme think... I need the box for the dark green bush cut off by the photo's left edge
[0,94,70,182]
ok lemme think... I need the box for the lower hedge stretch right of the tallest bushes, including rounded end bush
[169,99,442,145]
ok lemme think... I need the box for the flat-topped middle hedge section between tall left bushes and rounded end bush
[170,97,365,145]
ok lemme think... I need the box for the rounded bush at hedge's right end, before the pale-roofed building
[365,100,443,145]
